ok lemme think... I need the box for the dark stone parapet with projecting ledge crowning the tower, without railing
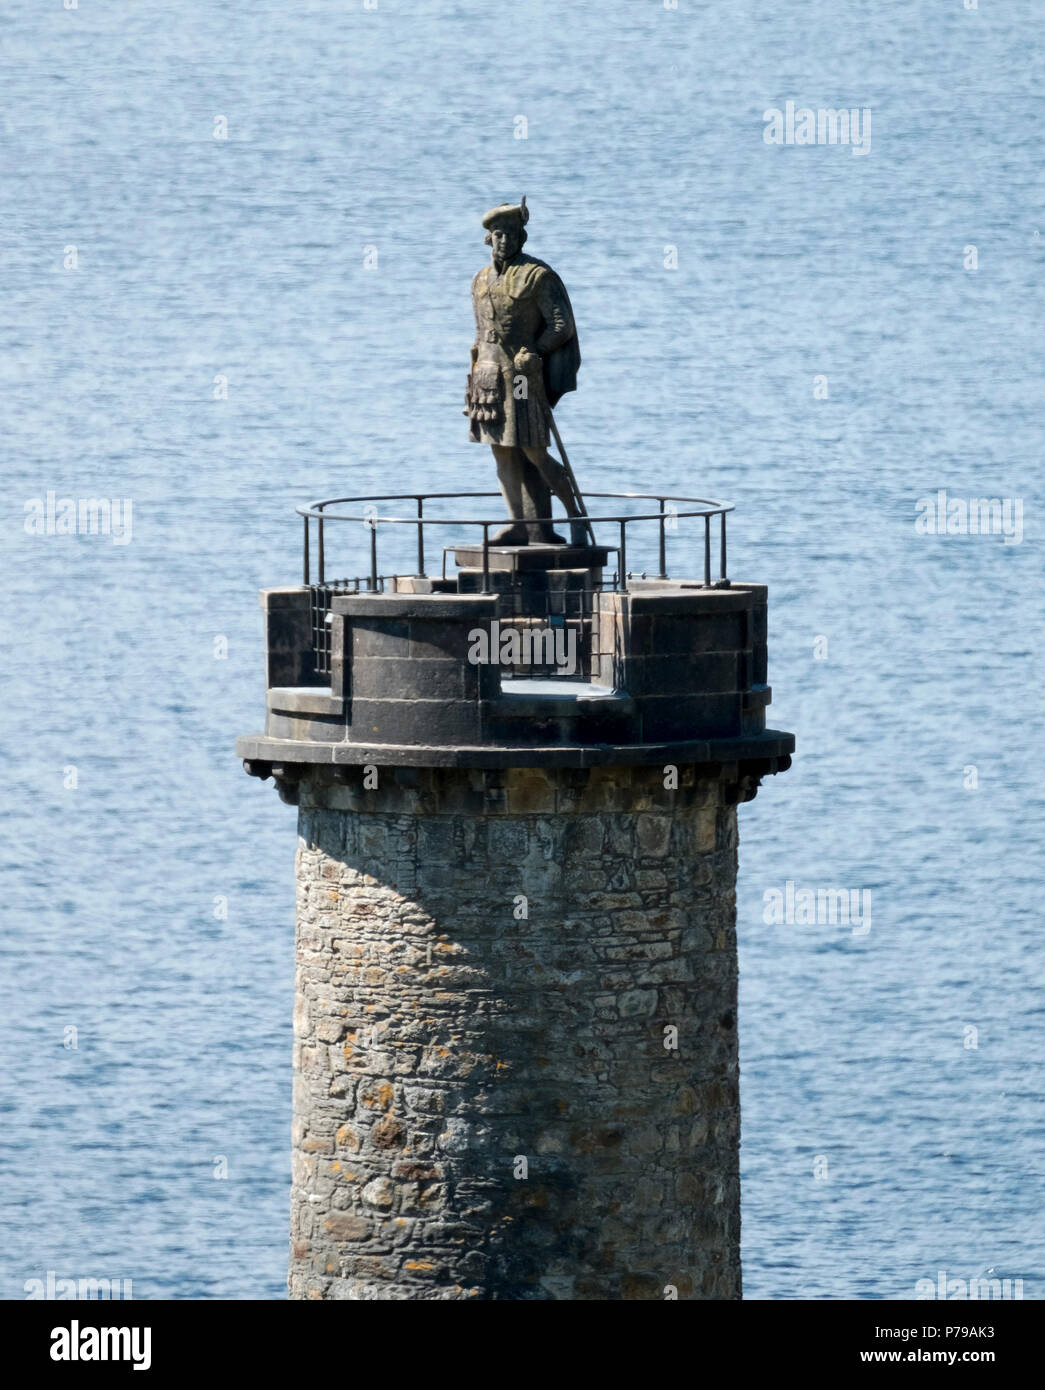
[238,580,795,783]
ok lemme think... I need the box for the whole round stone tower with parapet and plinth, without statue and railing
[238,533,793,1300]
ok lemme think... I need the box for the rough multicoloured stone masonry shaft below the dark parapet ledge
[289,767,741,1300]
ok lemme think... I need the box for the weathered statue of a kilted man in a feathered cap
[466,197,588,545]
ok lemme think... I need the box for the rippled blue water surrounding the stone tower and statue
[0,0,1045,1300]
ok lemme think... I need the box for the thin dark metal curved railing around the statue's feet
[296,492,734,594]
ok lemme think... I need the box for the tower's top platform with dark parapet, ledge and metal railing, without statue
[236,496,795,798]
